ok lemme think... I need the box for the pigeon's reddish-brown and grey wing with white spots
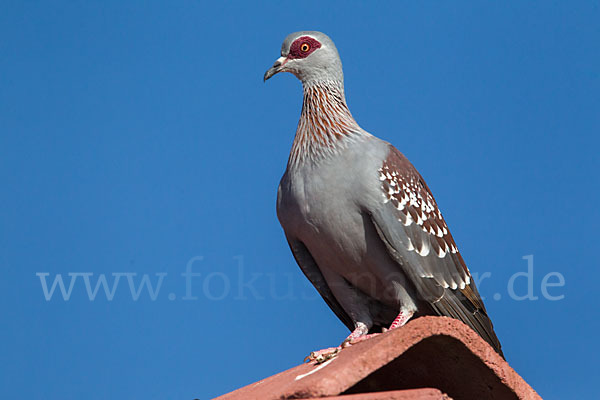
[368,145,502,354]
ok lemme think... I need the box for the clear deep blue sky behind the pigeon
[0,1,600,400]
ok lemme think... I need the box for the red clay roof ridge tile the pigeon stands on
[217,317,541,400]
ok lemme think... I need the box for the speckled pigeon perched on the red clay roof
[264,31,502,361]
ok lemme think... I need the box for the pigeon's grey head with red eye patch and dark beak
[264,31,344,83]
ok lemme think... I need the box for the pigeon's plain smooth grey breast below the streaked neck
[278,139,408,302]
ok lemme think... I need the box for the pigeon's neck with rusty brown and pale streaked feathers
[288,81,370,166]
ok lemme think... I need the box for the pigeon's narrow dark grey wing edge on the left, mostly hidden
[287,237,355,331]
